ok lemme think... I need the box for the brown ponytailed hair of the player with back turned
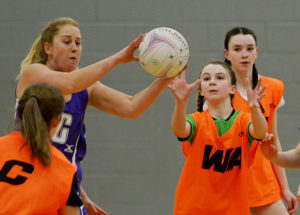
[17,84,65,165]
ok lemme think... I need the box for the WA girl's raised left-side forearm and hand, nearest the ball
[169,72,201,138]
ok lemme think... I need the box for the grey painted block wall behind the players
[0,0,300,215]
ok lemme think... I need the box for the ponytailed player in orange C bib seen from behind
[0,84,83,215]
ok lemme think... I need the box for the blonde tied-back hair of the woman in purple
[17,17,79,80]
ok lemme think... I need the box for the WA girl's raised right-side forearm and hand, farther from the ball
[246,79,268,139]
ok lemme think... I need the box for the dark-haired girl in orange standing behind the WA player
[224,27,297,215]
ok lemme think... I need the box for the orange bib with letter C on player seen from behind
[0,132,76,215]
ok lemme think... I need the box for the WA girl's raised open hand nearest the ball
[169,71,201,101]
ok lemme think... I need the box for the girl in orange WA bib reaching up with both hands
[169,61,267,215]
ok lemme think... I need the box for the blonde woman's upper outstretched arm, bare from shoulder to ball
[17,34,144,98]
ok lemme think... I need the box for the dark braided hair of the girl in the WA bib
[197,60,236,112]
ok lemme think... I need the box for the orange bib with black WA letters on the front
[174,111,251,215]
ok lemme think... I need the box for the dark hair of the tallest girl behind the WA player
[224,27,265,113]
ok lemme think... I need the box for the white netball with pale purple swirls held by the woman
[138,27,189,78]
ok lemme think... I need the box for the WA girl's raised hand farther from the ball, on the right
[246,79,266,109]
